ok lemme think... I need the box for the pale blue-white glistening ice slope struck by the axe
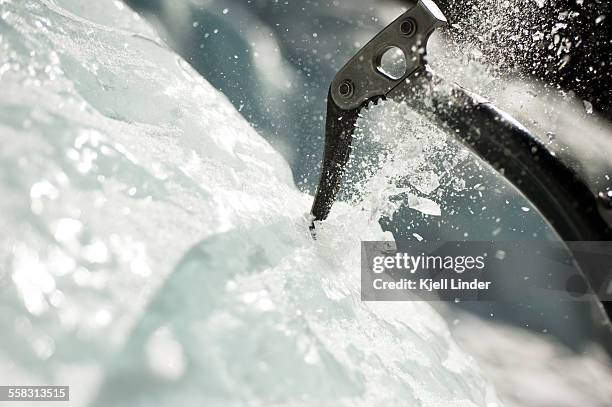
[0,0,497,406]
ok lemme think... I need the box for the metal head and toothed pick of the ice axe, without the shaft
[311,0,446,229]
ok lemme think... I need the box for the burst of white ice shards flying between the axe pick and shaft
[349,101,467,223]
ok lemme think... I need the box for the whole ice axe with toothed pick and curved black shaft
[311,0,612,324]
